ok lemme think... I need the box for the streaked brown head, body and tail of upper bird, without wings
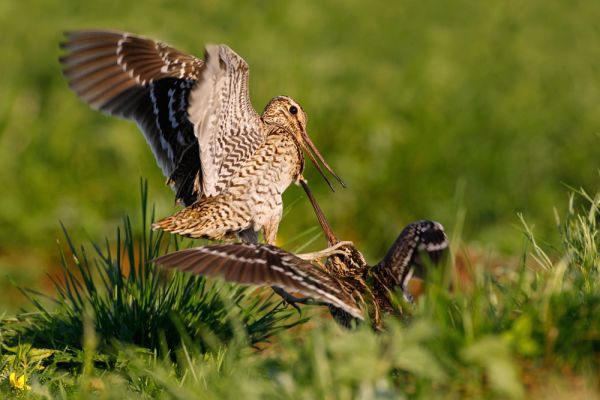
[153,96,342,244]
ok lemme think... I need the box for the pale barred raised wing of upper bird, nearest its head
[188,45,265,196]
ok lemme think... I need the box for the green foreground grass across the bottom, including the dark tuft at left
[0,192,600,399]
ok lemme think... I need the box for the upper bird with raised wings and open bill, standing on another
[60,30,345,244]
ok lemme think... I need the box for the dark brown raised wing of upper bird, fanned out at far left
[60,31,204,204]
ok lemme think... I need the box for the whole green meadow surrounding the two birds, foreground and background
[0,0,600,399]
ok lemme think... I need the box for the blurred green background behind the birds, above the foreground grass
[0,0,600,311]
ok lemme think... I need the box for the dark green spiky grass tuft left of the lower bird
[2,184,303,370]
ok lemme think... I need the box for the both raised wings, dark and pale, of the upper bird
[60,31,264,205]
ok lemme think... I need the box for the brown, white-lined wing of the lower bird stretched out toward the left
[155,244,364,319]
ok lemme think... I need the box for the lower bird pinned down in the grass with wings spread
[154,212,448,330]
